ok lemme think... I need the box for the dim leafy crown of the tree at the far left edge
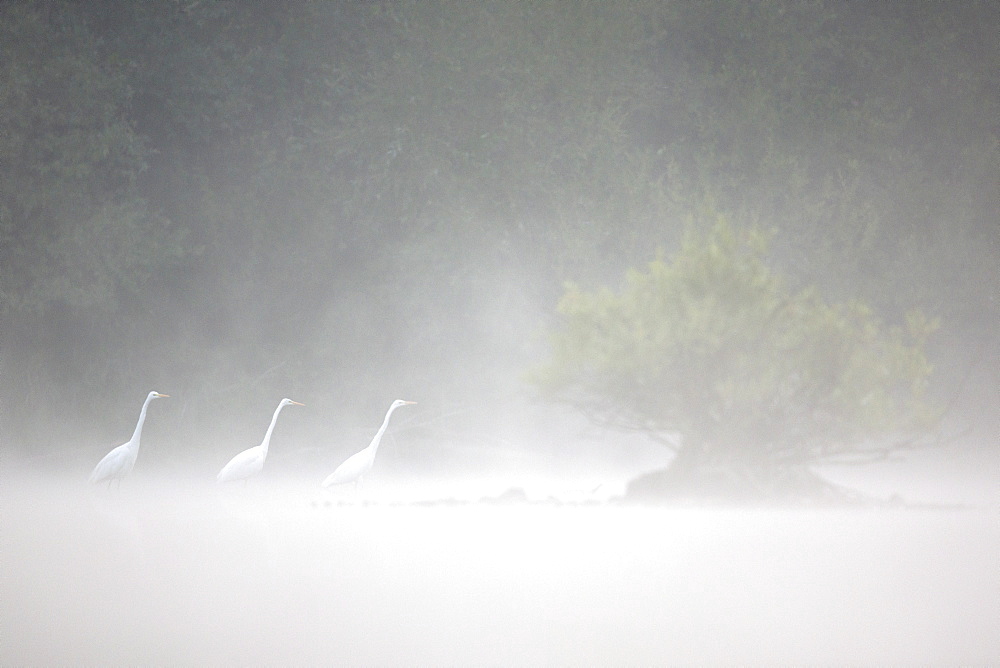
[0,3,177,317]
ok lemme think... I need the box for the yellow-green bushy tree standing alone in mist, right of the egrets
[536,215,936,495]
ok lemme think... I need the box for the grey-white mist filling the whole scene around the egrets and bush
[0,0,1000,665]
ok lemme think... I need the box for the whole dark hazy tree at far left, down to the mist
[0,2,188,434]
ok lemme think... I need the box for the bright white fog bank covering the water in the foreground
[0,472,1000,665]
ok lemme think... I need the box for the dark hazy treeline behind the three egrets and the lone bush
[0,0,1000,451]
